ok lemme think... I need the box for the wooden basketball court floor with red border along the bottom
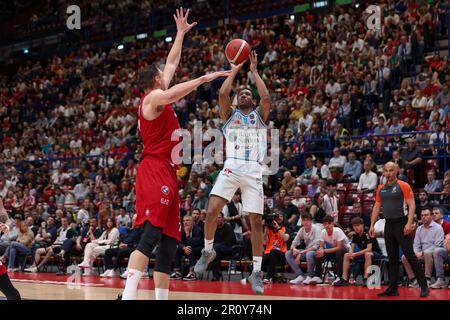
[1,272,450,300]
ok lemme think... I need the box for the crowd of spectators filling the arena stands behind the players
[0,1,450,283]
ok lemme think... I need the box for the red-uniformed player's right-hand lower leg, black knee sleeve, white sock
[153,234,178,300]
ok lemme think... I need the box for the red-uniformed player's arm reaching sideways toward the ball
[142,71,231,119]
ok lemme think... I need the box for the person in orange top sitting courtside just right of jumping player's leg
[262,213,289,283]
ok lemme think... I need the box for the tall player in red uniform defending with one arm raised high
[119,8,231,300]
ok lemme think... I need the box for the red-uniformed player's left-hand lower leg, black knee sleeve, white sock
[122,221,163,300]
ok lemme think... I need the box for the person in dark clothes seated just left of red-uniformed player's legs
[100,214,144,278]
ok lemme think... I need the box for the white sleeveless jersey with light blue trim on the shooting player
[222,108,267,174]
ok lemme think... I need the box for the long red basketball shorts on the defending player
[136,157,181,241]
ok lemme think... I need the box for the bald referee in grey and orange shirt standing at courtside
[369,162,430,297]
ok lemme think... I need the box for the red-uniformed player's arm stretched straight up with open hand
[163,7,197,88]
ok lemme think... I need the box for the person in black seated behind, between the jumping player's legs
[211,212,236,281]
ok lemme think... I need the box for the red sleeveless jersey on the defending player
[139,92,181,165]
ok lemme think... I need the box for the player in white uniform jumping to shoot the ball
[194,51,270,294]
